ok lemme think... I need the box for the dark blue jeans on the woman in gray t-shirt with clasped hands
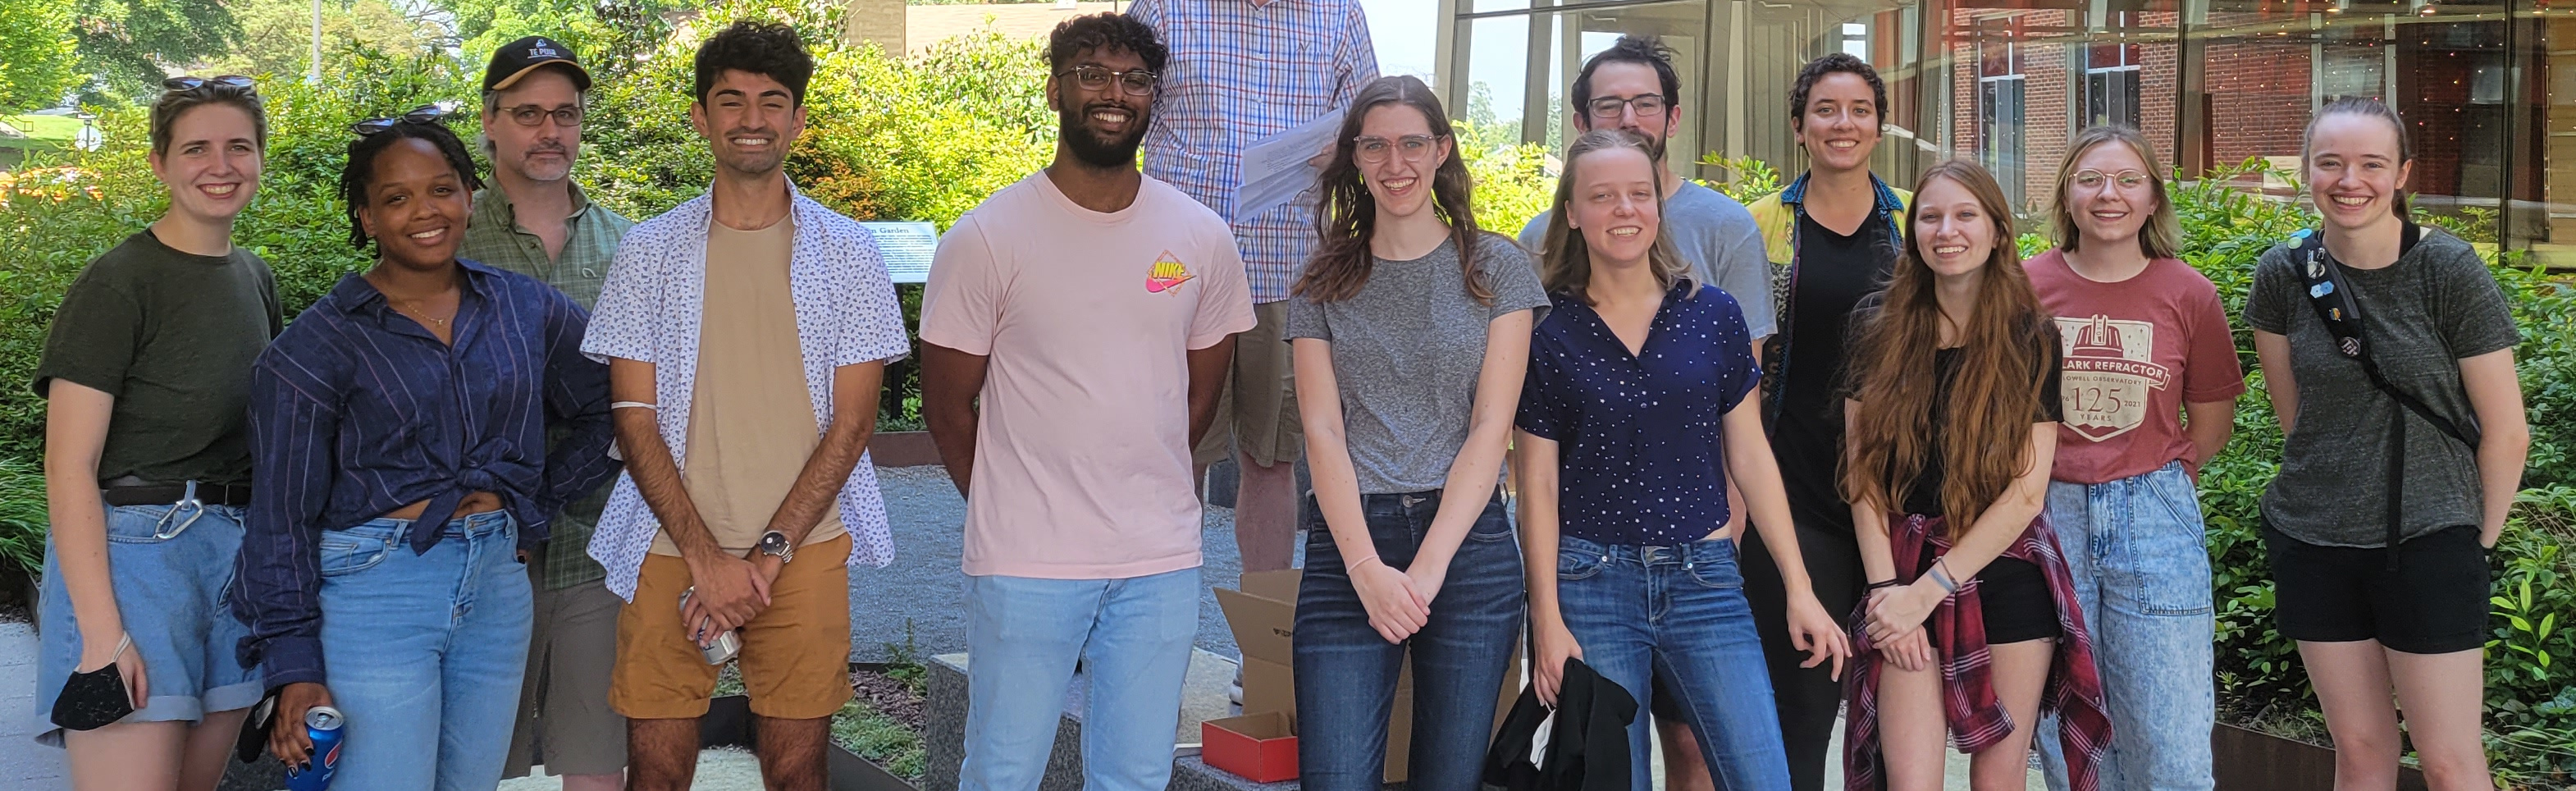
[1295,492,1525,791]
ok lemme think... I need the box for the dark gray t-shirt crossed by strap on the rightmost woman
[2246,229,2522,546]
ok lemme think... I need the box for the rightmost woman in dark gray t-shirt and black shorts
[2246,98,2529,789]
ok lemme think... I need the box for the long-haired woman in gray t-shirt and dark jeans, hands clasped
[1288,77,1548,791]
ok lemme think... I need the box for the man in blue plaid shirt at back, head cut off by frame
[1128,0,1378,572]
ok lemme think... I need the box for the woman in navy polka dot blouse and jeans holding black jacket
[1514,129,1850,791]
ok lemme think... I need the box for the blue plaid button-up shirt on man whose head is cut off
[1128,0,1378,304]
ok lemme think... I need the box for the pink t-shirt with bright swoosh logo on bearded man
[922,170,1252,580]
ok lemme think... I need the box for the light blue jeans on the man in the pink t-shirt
[958,567,1198,791]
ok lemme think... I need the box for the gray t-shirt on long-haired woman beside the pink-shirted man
[1288,235,1548,495]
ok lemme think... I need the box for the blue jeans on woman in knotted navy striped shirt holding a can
[319,510,536,791]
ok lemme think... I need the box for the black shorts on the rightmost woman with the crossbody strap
[2262,526,2488,655]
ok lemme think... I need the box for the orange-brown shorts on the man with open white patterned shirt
[608,536,852,719]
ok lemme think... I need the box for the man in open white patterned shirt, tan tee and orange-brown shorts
[582,23,912,791]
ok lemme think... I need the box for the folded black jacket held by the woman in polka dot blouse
[1484,660,1636,791]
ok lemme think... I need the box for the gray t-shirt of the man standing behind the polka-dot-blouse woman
[1520,183,1780,340]
